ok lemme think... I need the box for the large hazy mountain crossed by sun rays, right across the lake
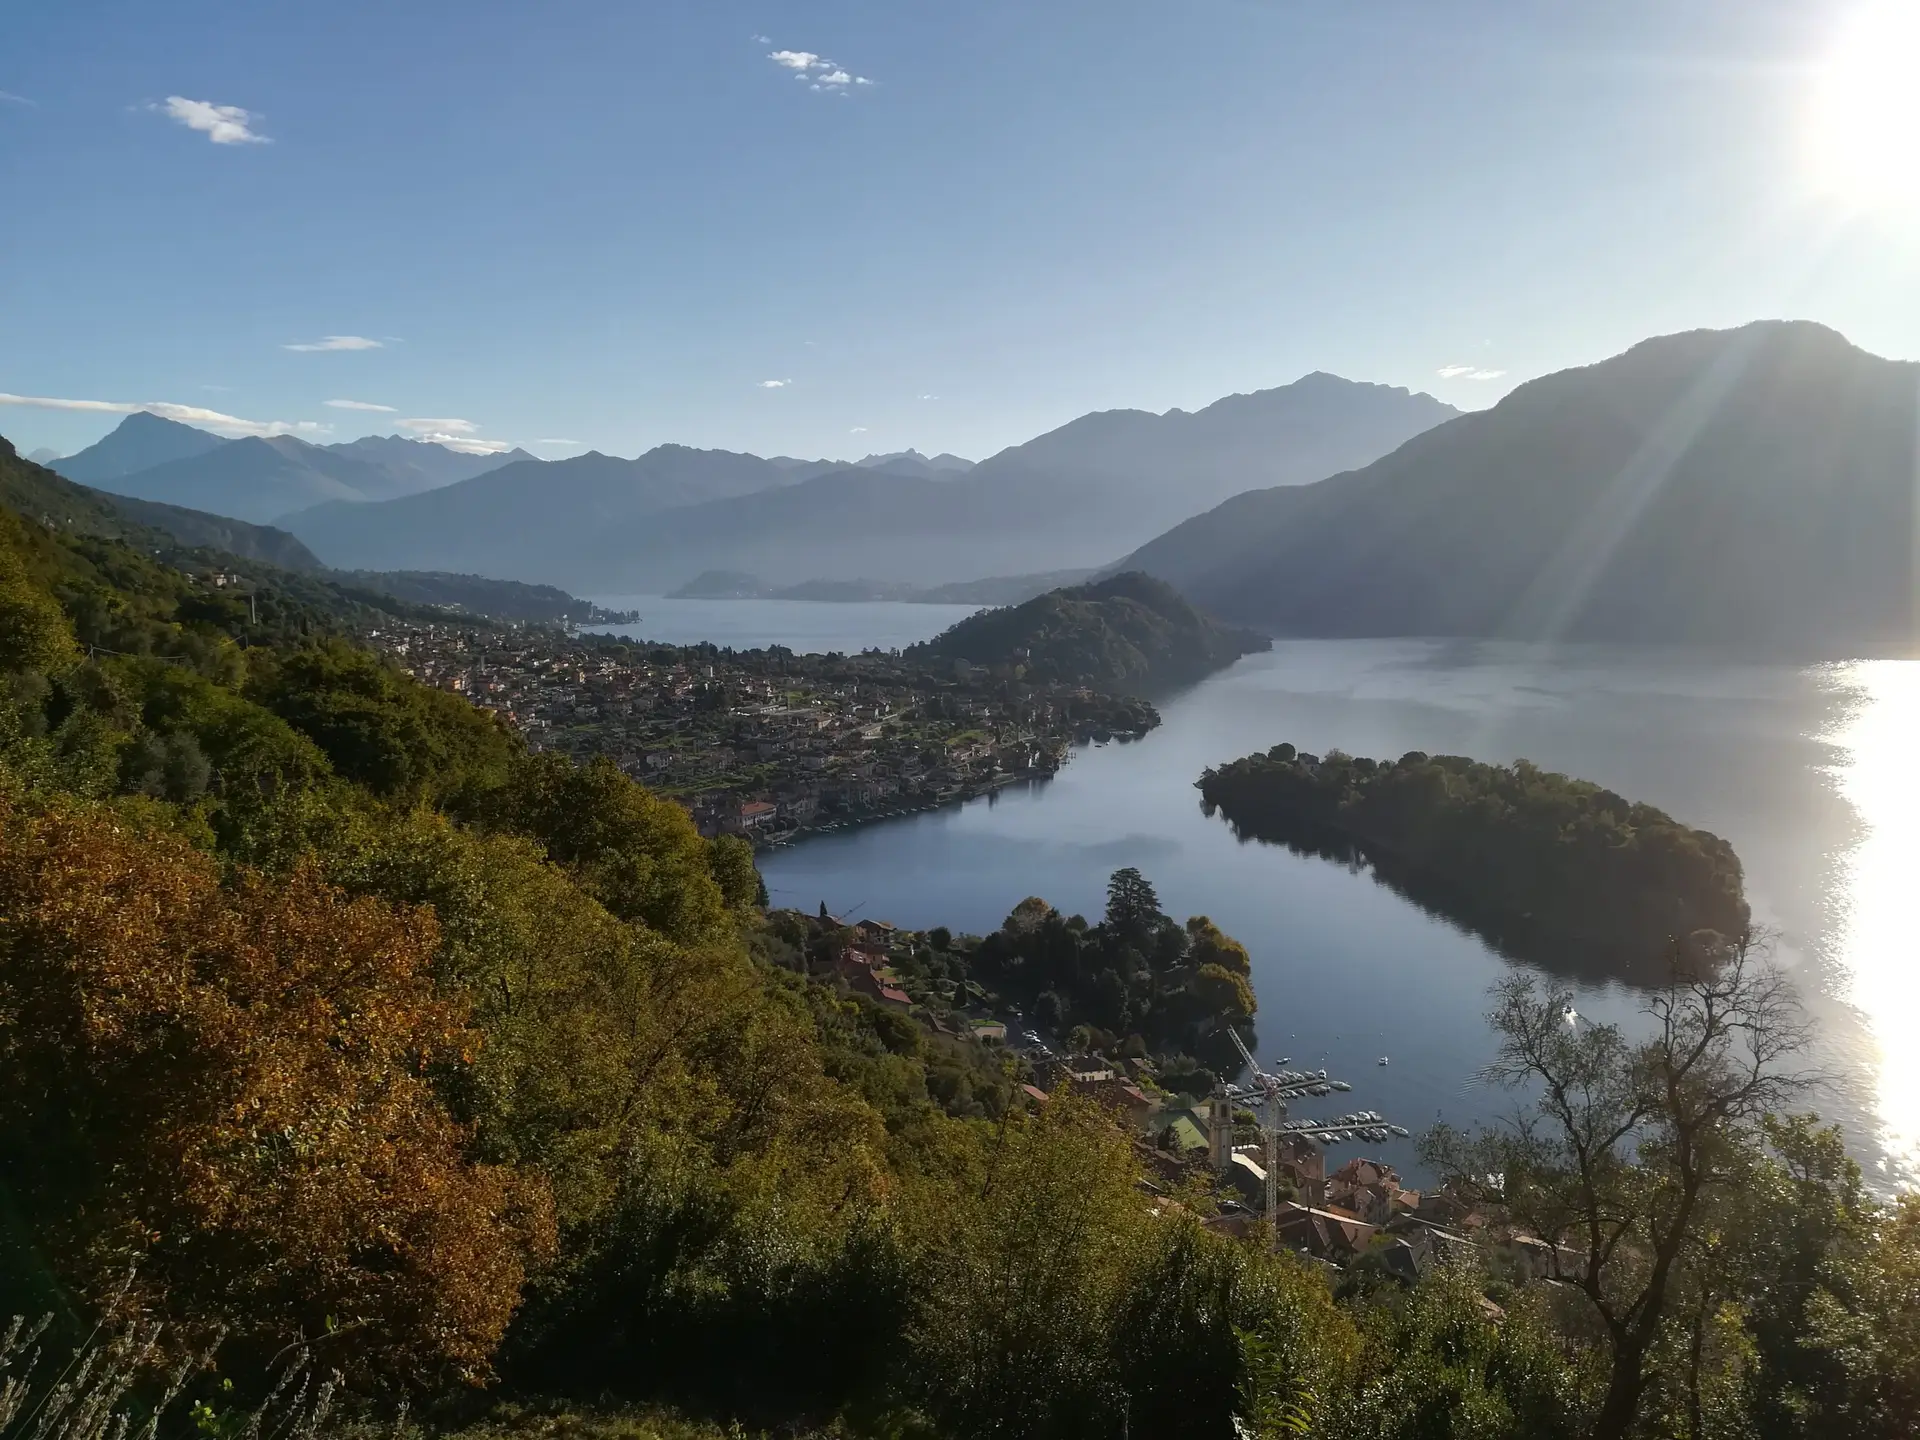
[1125,323,1920,647]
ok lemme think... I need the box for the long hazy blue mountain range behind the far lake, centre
[282,374,1457,593]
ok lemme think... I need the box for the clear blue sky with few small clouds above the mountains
[0,0,1920,459]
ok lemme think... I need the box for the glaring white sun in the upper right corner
[1807,0,1920,209]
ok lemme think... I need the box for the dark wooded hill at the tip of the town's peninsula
[906,570,1273,695]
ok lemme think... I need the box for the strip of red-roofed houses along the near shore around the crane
[768,906,1582,1306]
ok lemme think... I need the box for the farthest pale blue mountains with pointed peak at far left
[52,411,540,524]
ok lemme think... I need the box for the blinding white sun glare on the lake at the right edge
[1828,660,1920,1173]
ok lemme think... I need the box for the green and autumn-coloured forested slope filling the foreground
[0,432,1920,1440]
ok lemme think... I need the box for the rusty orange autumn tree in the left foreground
[0,783,549,1382]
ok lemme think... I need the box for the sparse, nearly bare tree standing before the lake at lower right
[1425,941,1811,1440]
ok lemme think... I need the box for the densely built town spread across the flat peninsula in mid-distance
[367,620,1160,847]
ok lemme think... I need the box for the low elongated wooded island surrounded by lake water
[1196,745,1751,979]
